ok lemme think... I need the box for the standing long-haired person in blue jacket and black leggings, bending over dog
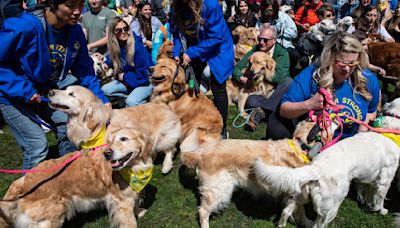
[170,0,234,137]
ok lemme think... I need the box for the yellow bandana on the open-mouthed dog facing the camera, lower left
[119,166,153,193]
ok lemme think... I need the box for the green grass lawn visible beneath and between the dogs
[0,108,400,228]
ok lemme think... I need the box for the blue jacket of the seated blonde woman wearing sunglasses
[105,33,153,89]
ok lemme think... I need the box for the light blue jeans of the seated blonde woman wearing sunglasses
[101,80,153,107]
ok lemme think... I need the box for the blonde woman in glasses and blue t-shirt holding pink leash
[267,32,380,138]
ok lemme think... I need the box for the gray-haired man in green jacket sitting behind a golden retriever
[233,24,291,131]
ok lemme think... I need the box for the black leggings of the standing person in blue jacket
[190,59,228,131]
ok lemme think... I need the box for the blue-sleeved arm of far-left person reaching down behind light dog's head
[70,26,109,104]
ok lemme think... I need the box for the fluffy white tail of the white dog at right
[254,159,319,195]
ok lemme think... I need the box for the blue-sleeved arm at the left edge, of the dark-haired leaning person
[0,18,52,102]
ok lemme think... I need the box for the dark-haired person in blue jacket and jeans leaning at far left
[0,0,108,169]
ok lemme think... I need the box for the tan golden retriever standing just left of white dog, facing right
[181,121,322,228]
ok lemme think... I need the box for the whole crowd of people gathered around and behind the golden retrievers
[0,0,400,169]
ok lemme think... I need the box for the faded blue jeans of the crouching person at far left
[0,104,77,169]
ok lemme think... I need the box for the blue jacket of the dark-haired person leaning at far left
[0,13,109,104]
